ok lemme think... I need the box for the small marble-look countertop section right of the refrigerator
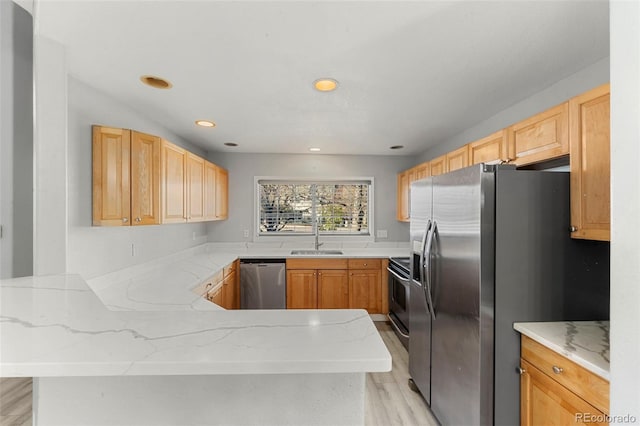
[513,321,610,380]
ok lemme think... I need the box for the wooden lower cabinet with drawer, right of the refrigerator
[520,336,609,426]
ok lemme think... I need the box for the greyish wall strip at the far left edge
[0,0,33,278]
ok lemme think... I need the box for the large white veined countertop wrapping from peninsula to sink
[0,244,408,377]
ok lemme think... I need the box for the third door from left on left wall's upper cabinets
[161,140,187,223]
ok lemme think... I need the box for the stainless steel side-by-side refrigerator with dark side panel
[409,165,609,425]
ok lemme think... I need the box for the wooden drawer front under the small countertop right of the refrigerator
[522,336,609,414]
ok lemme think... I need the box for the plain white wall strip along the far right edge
[610,0,640,424]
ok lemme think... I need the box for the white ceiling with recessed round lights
[35,0,609,155]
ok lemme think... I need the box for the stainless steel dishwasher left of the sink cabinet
[240,259,287,309]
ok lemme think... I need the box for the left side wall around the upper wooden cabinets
[67,76,207,278]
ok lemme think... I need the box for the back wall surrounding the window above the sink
[209,153,411,242]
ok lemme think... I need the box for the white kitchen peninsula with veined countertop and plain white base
[0,243,400,425]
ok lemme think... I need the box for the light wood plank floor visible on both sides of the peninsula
[0,322,438,426]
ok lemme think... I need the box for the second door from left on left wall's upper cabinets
[131,131,161,225]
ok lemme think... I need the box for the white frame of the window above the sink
[253,176,375,243]
